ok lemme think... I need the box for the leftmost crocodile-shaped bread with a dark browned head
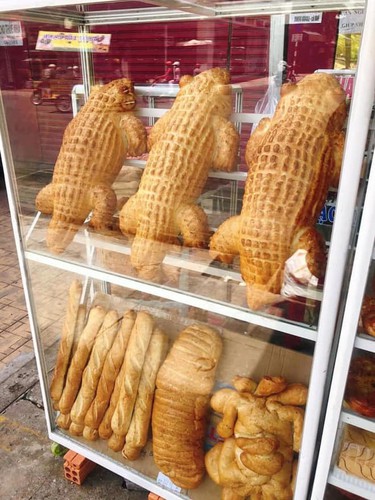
[36,78,147,253]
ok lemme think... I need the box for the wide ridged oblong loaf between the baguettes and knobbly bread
[152,325,222,489]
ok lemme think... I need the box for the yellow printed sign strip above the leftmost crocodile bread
[35,31,111,52]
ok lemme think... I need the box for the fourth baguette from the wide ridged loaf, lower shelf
[70,310,119,425]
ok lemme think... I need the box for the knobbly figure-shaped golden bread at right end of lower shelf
[205,376,307,500]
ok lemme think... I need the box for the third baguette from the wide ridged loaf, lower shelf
[85,311,136,433]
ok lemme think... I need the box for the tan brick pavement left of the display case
[0,189,33,370]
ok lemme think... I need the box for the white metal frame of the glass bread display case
[0,0,375,500]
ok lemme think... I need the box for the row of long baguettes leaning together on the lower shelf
[50,280,168,460]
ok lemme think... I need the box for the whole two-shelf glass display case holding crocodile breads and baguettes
[0,0,375,499]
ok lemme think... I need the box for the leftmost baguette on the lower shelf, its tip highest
[50,280,82,407]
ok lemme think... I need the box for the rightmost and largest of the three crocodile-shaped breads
[210,73,346,309]
